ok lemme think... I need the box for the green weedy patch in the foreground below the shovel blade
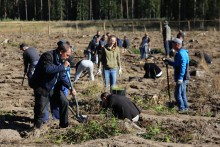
[46,118,127,144]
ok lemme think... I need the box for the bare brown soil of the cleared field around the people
[0,31,220,146]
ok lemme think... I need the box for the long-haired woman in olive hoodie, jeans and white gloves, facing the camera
[97,35,122,89]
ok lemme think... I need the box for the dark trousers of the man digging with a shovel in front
[34,90,69,128]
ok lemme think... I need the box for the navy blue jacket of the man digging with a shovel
[30,50,70,93]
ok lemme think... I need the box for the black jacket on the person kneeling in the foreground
[107,94,141,120]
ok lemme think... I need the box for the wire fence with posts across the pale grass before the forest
[0,19,220,35]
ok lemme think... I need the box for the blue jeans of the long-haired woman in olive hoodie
[104,68,117,88]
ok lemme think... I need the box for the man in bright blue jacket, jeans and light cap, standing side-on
[164,38,189,113]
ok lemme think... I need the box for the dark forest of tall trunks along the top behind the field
[0,0,220,21]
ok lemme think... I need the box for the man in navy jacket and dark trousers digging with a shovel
[31,43,76,128]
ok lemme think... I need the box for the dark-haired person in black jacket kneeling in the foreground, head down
[101,92,141,122]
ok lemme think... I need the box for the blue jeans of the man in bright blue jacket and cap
[174,81,188,110]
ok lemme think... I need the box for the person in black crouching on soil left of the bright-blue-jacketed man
[144,57,163,79]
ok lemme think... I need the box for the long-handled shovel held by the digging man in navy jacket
[67,73,88,123]
